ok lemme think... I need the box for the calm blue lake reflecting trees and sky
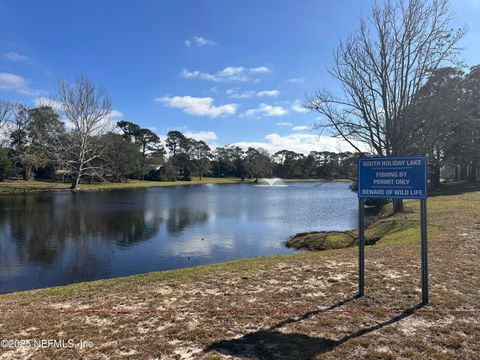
[0,182,357,293]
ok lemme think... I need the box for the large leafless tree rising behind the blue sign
[305,0,467,211]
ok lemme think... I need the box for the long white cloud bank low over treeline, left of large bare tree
[232,134,365,155]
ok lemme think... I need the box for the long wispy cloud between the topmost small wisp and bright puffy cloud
[180,66,271,82]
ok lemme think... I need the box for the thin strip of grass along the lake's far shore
[0,177,350,195]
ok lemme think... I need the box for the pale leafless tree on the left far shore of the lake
[54,76,111,190]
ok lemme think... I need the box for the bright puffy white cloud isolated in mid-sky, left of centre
[155,96,238,117]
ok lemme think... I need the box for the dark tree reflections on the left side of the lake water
[0,191,208,270]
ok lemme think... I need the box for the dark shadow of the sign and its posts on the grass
[204,298,422,360]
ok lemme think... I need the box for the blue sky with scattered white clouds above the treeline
[0,0,480,153]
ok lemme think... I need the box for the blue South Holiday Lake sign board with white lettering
[358,156,427,199]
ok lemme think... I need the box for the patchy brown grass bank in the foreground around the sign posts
[0,185,480,359]
